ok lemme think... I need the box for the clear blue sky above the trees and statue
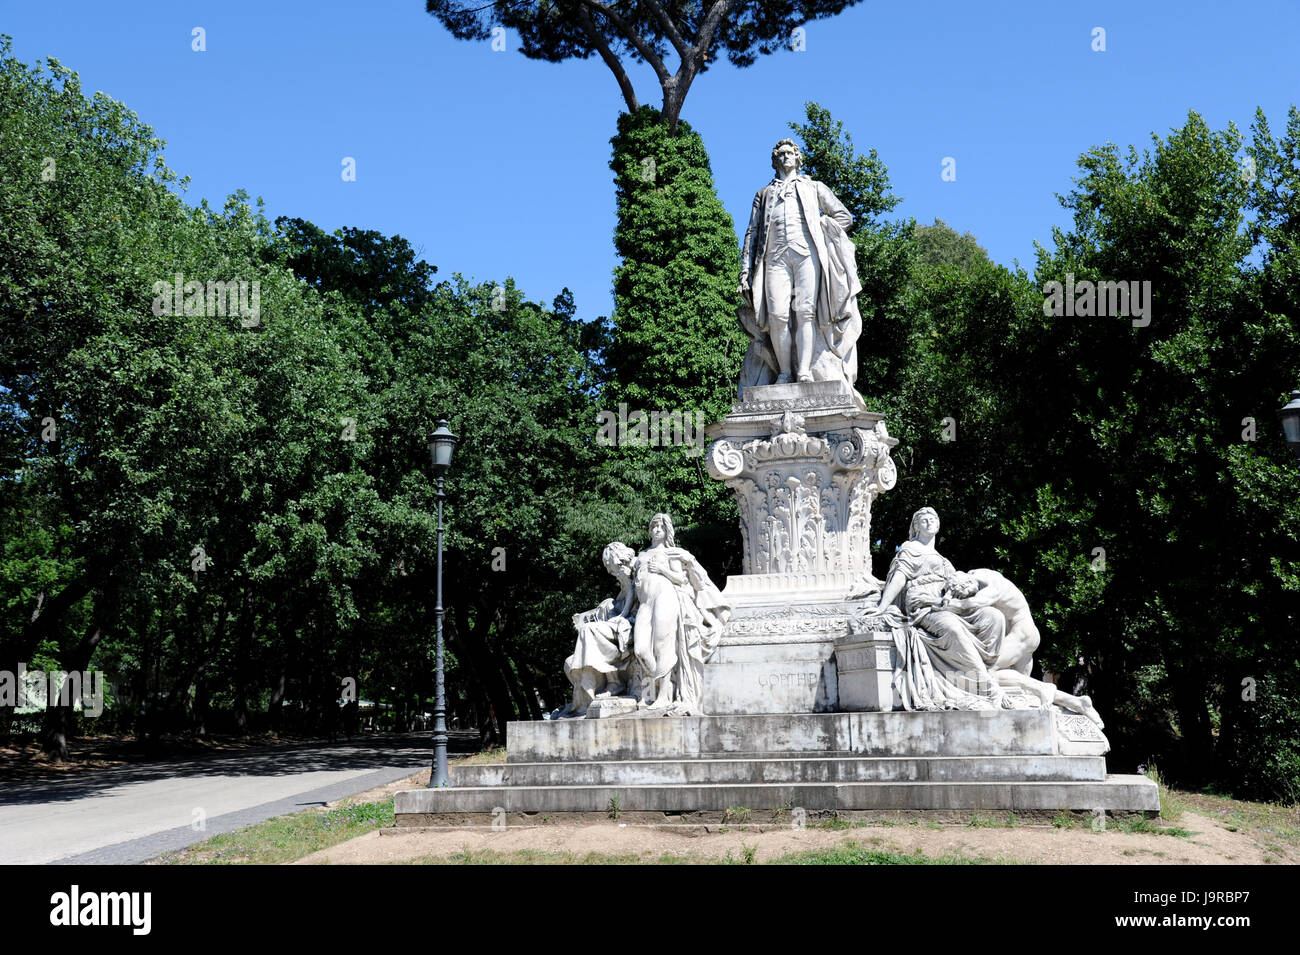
[0,0,1300,318]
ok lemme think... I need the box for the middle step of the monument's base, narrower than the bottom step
[451,754,1106,789]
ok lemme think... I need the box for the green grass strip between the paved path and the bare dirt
[155,796,393,865]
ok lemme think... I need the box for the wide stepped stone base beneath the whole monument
[395,709,1160,826]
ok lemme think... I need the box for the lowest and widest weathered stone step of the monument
[395,776,1160,826]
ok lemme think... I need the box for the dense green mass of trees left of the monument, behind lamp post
[0,41,642,751]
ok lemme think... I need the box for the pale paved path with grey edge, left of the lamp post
[0,734,430,864]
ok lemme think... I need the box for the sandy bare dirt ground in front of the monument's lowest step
[295,774,1300,865]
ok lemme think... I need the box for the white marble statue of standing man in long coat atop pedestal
[737,139,862,387]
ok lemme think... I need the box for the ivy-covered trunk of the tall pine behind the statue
[610,107,745,569]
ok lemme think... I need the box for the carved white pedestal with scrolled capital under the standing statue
[703,382,898,715]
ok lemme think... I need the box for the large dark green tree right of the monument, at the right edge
[1014,113,1300,787]
